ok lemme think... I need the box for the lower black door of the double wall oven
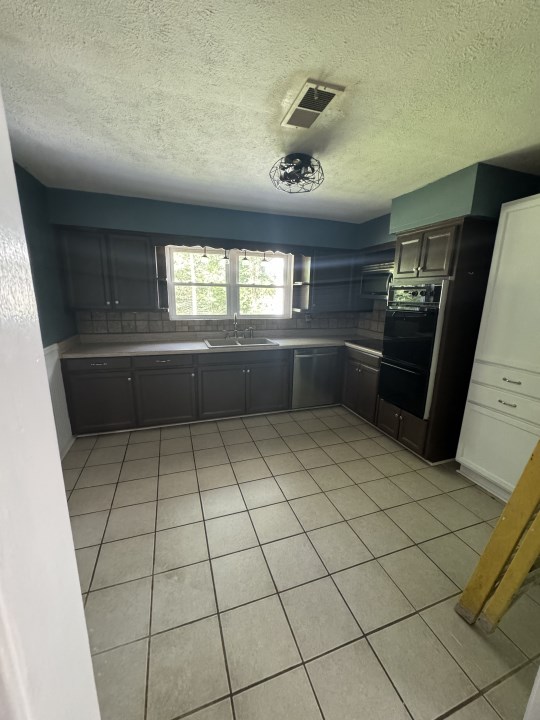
[379,359,429,418]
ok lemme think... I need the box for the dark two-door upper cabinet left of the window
[62,229,158,310]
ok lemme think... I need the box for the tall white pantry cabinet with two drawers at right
[457,195,540,499]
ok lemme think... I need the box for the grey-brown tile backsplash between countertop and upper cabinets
[77,301,385,335]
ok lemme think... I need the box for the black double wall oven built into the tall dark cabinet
[379,281,447,419]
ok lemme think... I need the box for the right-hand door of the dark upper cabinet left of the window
[109,235,158,310]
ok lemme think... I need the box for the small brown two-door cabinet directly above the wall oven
[394,225,456,278]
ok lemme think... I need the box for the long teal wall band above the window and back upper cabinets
[47,188,391,250]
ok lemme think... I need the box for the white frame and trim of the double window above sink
[166,245,294,321]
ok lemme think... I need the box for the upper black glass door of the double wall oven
[383,308,439,370]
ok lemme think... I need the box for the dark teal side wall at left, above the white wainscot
[15,165,76,347]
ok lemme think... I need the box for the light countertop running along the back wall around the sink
[61,336,382,359]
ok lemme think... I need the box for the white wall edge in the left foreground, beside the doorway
[0,87,99,720]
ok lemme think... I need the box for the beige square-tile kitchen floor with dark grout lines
[64,407,540,720]
